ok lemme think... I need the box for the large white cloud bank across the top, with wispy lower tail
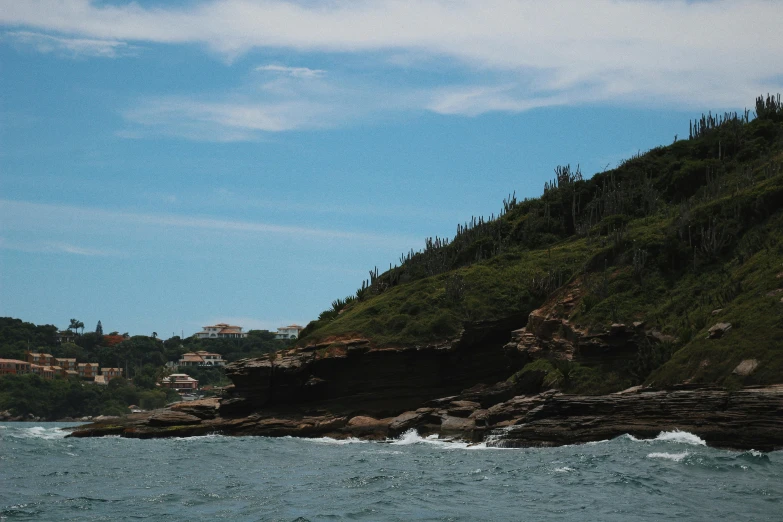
[0,0,783,120]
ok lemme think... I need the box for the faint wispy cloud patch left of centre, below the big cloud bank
[120,61,420,138]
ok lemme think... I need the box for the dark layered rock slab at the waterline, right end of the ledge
[474,385,783,451]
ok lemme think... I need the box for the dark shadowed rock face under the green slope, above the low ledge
[221,317,525,416]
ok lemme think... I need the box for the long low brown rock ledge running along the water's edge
[70,383,783,451]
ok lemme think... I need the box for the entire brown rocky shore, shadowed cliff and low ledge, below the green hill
[69,308,783,451]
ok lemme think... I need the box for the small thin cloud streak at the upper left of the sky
[3,31,139,58]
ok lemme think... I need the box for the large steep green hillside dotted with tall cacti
[300,95,783,387]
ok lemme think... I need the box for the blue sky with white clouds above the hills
[0,0,783,338]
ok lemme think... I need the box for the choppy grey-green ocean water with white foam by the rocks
[0,423,783,522]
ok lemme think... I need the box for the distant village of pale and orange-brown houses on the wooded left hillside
[0,321,304,394]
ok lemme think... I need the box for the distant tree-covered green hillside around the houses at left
[0,317,291,420]
